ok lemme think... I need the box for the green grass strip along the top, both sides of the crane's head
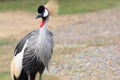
[0,0,120,14]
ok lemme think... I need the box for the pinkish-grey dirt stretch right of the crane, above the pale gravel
[55,9,120,44]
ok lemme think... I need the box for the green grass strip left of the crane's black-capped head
[0,0,46,12]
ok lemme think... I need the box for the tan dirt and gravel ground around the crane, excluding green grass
[0,8,120,80]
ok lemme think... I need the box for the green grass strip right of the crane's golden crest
[60,0,120,14]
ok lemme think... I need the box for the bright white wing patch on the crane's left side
[13,40,28,77]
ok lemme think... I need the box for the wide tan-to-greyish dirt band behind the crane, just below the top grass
[0,8,120,44]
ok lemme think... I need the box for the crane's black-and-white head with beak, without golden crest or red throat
[36,5,49,20]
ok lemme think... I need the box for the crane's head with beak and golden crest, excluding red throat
[36,0,59,19]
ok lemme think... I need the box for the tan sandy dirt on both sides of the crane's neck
[0,12,80,38]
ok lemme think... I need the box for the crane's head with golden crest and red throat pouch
[36,0,59,28]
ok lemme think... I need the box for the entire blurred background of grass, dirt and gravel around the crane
[0,0,120,80]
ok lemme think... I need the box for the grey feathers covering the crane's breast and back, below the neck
[15,29,54,74]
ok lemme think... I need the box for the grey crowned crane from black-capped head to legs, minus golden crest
[11,2,58,80]
